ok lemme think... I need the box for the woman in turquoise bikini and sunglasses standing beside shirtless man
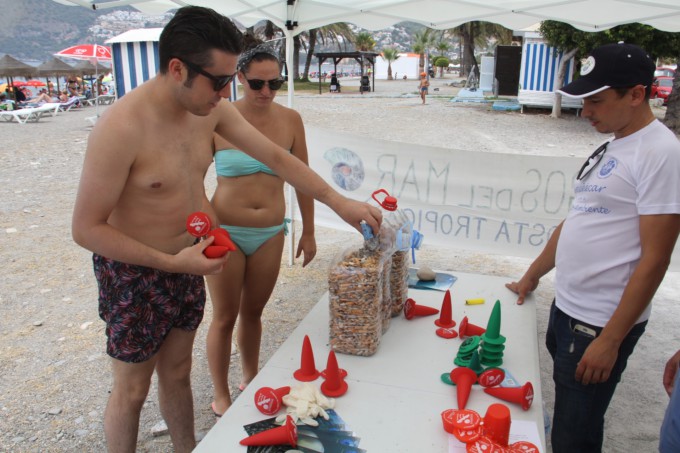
[207,40,316,416]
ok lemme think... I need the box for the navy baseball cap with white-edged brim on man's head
[557,42,656,99]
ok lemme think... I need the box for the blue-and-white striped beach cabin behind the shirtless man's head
[106,28,237,101]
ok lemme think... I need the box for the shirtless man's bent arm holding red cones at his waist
[71,125,226,275]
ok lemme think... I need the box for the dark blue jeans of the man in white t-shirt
[545,301,647,453]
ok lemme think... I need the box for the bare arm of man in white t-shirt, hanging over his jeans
[576,214,680,385]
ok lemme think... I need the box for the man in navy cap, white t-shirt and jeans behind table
[506,43,680,453]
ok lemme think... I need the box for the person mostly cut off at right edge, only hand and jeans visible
[659,350,680,453]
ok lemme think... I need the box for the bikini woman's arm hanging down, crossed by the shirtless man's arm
[287,110,316,267]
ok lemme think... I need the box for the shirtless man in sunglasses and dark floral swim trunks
[72,7,381,452]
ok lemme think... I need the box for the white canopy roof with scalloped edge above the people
[54,0,680,35]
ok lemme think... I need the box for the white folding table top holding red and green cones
[195,272,545,453]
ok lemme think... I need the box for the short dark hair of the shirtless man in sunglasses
[158,6,243,79]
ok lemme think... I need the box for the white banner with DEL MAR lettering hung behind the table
[296,126,680,270]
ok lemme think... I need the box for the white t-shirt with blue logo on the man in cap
[555,120,680,326]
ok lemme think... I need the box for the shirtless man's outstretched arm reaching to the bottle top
[215,102,382,234]
